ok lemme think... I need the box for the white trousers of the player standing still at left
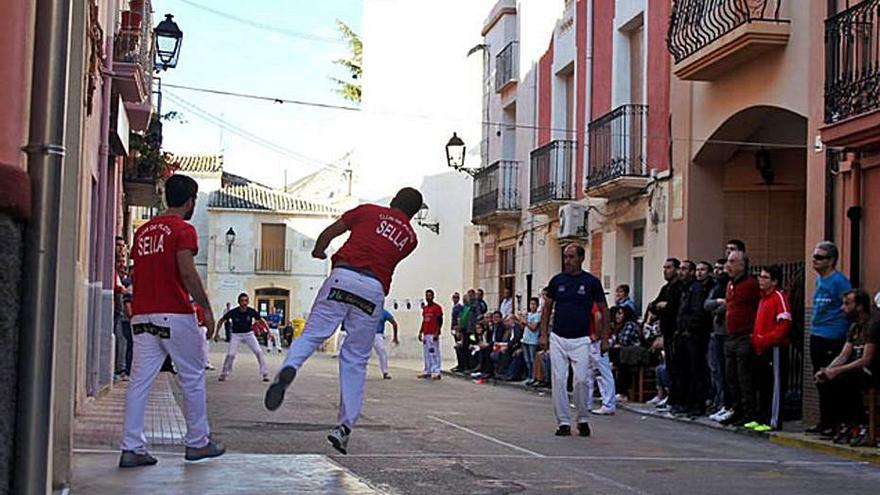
[121,313,210,453]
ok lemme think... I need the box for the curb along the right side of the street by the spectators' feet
[441,370,880,465]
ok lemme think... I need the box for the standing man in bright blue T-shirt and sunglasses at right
[807,241,852,433]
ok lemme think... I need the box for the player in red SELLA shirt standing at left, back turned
[119,175,226,468]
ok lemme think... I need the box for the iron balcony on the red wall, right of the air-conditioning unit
[586,105,649,199]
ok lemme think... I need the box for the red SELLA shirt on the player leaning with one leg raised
[333,204,418,294]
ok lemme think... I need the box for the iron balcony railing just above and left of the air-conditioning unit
[529,140,575,206]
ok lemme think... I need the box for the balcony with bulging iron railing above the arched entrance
[666,0,791,81]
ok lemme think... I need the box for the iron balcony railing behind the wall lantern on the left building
[113,0,154,91]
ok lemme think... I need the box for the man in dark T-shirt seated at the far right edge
[815,289,880,446]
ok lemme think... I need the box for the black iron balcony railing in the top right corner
[825,0,880,124]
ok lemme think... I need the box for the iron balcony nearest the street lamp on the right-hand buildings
[471,160,520,225]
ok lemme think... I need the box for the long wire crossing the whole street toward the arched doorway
[164,83,809,149]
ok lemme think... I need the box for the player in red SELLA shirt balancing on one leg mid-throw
[264,187,422,454]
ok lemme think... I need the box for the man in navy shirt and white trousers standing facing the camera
[540,244,608,437]
